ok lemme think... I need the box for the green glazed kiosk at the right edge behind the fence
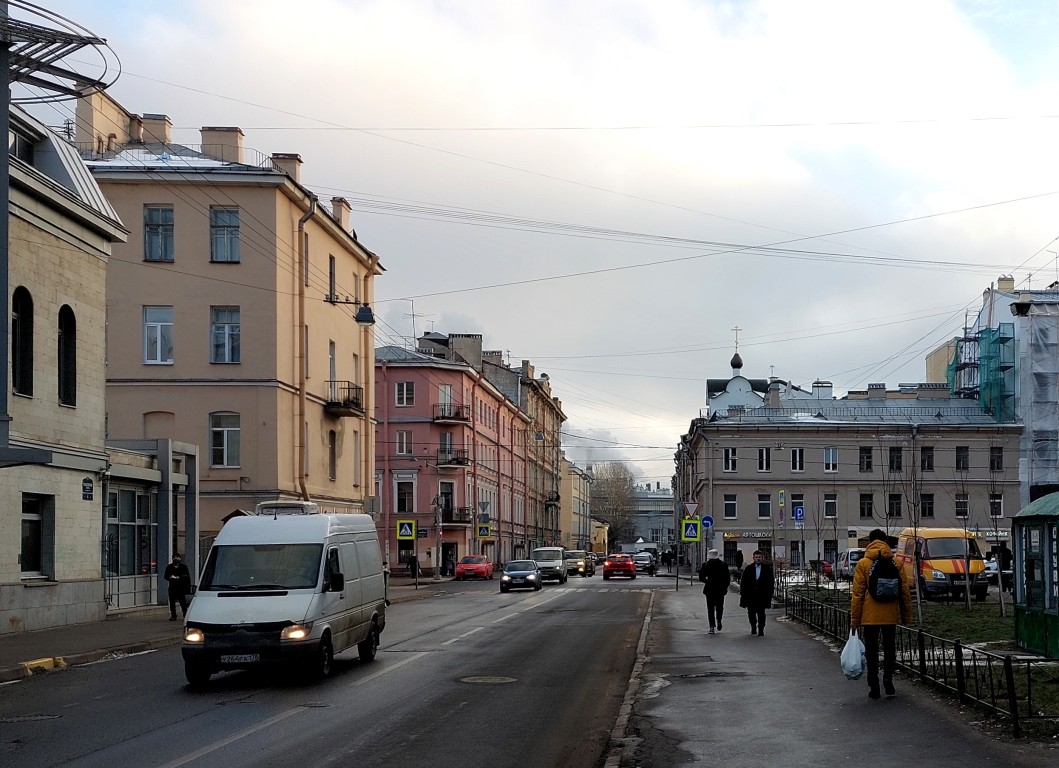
[1011,493,1059,659]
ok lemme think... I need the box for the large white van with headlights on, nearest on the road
[181,502,387,686]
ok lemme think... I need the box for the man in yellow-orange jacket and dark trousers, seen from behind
[849,529,912,699]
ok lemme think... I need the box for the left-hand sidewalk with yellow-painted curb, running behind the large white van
[0,576,451,683]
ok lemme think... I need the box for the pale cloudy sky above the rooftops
[12,0,1059,488]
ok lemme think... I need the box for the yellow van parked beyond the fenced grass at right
[894,528,989,602]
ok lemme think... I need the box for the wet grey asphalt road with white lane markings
[0,575,660,768]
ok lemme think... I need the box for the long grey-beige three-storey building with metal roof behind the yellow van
[676,361,1022,567]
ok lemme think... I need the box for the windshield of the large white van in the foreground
[198,543,323,591]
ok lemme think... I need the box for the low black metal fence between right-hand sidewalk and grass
[784,590,1059,736]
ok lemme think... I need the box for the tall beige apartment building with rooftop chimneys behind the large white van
[76,93,382,547]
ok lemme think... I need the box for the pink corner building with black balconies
[375,346,533,571]
